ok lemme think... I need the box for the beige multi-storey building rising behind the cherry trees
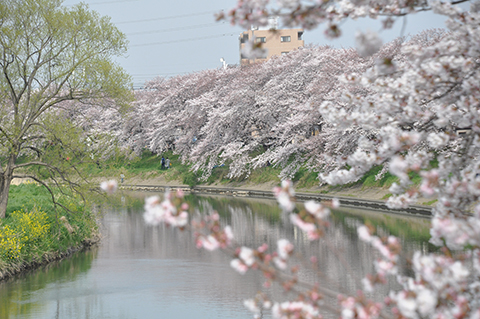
[239,29,304,65]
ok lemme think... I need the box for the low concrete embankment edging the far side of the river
[120,184,432,218]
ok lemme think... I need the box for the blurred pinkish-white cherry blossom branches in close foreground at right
[214,1,480,318]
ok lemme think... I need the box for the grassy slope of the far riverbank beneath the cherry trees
[61,151,436,207]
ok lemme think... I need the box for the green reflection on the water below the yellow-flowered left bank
[0,247,98,318]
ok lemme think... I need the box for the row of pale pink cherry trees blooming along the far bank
[123,47,382,181]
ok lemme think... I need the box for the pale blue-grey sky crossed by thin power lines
[64,0,454,89]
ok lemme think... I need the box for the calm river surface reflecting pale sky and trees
[0,194,431,319]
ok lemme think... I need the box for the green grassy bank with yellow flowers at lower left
[0,184,99,279]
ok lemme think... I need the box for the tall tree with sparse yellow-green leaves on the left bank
[0,0,133,218]
